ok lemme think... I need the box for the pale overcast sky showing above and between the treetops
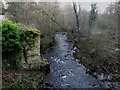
[2,0,118,13]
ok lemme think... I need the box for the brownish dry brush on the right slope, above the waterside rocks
[75,29,120,75]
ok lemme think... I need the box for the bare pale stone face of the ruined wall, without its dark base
[22,36,42,68]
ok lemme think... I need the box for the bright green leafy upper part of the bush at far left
[2,20,22,52]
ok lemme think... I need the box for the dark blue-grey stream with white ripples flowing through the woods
[45,32,102,88]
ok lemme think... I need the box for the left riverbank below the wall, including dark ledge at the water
[2,58,50,89]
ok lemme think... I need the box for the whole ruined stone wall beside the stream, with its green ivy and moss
[0,20,49,70]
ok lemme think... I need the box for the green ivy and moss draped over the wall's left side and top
[0,20,40,70]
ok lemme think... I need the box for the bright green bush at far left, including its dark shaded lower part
[0,20,22,69]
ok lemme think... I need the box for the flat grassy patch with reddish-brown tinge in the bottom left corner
[2,71,44,88]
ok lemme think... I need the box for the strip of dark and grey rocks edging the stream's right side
[74,48,120,88]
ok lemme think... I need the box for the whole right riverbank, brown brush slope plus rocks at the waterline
[74,31,120,88]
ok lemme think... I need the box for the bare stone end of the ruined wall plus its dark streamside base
[22,36,50,74]
